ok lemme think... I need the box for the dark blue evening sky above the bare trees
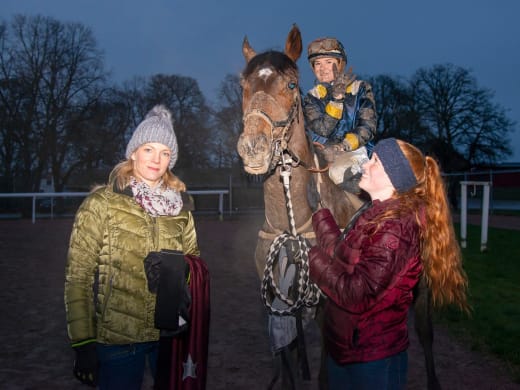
[4,0,520,162]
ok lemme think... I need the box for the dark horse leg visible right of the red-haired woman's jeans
[414,278,441,390]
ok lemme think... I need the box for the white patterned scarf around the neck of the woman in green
[130,177,182,217]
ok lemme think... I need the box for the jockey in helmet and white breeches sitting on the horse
[303,38,377,193]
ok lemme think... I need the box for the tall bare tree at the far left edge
[0,15,105,191]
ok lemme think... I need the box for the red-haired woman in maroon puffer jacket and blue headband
[310,138,469,389]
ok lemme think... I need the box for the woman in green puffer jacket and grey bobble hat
[65,105,199,390]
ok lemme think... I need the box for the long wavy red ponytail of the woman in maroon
[372,140,470,312]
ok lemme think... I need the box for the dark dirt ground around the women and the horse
[0,215,520,390]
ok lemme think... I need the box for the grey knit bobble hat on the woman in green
[125,105,178,169]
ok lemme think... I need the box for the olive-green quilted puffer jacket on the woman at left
[65,187,200,344]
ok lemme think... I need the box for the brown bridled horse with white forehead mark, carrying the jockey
[237,25,440,390]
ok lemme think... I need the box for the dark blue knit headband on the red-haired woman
[374,138,417,192]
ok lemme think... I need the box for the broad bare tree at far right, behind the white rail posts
[410,64,514,168]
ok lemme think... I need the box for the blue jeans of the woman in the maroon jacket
[327,351,408,390]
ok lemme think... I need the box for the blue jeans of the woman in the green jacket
[96,342,159,390]
